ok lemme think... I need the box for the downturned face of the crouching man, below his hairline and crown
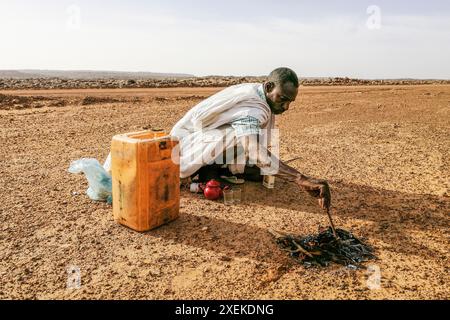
[264,82,298,114]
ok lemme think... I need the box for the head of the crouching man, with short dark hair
[264,68,299,114]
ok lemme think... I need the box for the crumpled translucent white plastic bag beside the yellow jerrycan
[69,158,112,203]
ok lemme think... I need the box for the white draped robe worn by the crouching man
[170,83,275,178]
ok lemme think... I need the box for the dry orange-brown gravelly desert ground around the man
[0,85,450,299]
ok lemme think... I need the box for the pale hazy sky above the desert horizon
[0,0,450,79]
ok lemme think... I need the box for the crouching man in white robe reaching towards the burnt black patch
[171,68,331,209]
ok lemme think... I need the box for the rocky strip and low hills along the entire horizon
[0,70,450,90]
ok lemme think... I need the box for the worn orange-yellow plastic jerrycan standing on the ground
[111,131,180,232]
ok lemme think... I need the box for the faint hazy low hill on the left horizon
[0,70,195,80]
